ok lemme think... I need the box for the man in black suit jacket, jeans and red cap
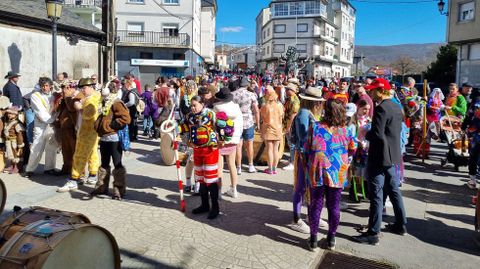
[354,78,407,245]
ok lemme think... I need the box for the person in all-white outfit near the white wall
[23,77,60,178]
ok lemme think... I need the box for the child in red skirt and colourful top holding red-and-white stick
[179,96,220,219]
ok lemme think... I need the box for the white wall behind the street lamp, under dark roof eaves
[0,24,98,92]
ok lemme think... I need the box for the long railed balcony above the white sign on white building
[117,30,190,48]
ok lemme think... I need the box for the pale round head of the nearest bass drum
[42,224,120,269]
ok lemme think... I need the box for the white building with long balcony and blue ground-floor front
[115,0,217,83]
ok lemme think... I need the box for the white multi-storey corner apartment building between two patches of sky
[256,0,356,78]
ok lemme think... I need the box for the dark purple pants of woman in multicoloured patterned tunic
[308,186,342,238]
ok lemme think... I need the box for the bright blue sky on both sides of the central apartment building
[217,0,447,45]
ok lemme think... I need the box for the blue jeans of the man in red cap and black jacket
[368,166,407,234]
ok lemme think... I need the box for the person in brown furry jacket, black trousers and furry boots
[91,79,131,200]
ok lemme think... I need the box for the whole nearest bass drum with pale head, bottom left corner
[0,220,120,269]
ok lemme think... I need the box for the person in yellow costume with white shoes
[57,78,101,192]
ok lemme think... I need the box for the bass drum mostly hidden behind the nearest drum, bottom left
[0,206,91,247]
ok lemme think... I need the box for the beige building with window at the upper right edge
[447,0,480,88]
